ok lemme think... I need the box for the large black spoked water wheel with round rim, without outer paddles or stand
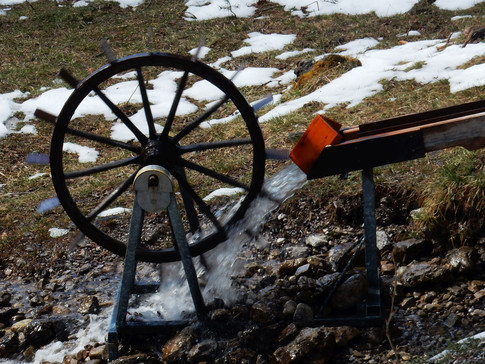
[50,53,265,262]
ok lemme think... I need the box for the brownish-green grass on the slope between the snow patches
[0,0,485,268]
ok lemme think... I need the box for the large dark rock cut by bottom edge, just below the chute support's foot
[273,327,335,364]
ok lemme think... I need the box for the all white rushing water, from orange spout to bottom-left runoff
[34,164,307,363]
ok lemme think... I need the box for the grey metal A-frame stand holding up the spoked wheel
[107,166,206,361]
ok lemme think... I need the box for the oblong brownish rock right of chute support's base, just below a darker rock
[396,260,449,287]
